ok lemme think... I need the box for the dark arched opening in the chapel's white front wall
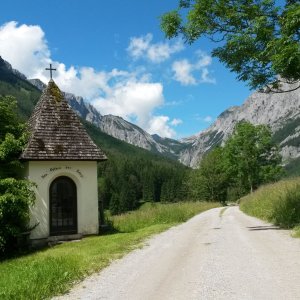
[49,176,77,235]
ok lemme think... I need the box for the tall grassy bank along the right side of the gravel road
[240,177,300,237]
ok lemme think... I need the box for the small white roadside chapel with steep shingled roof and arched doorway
[21,79,107,242]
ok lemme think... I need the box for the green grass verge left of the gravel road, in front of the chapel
[0,202,218,300]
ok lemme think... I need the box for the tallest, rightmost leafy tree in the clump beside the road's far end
[224,122,282,194]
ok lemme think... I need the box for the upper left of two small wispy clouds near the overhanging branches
[127,33,184,63]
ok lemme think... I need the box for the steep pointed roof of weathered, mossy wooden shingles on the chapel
[21,79,107,161]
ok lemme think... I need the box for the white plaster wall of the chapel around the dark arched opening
[27,161,99,239]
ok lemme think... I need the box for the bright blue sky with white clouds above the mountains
[0,0,251,138]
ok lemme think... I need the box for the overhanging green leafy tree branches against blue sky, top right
[161,0,300,89]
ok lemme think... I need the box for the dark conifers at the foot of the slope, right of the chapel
[98,155,188,215]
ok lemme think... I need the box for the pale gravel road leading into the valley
[56,207,300,300]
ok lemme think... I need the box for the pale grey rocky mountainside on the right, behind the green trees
[180,86,300,167]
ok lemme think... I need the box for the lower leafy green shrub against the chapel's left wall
[0,178,35,258]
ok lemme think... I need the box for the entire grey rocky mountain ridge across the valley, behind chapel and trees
[1,56,300,168]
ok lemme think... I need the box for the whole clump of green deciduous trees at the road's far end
[187,122,283,202]
